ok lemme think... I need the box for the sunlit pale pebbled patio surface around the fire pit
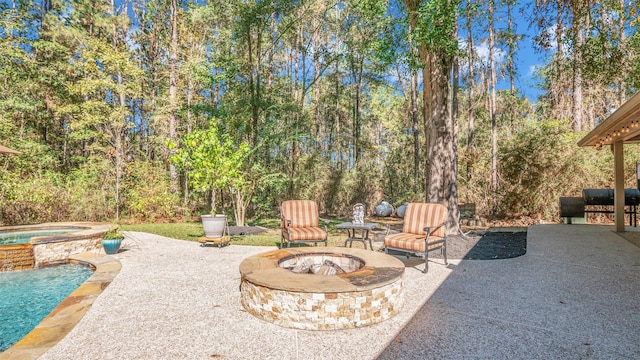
[41,232,459,360]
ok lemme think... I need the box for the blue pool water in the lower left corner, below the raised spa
[0,264,93,352]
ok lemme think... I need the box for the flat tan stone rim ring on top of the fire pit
[240,246,405,293]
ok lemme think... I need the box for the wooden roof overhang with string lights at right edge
[578,91,640,148]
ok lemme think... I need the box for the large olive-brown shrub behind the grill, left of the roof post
[498,121,616,221]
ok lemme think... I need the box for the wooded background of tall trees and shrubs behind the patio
[0,0,640,228]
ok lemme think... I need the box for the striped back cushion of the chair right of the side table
[402,203,448,237]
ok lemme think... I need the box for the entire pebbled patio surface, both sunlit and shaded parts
[32,225,640,359]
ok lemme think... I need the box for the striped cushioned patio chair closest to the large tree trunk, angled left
[384,203,448,273]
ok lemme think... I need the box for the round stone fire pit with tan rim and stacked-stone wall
[240,247,404,330]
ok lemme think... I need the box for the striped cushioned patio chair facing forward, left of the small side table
[280,200,328,248]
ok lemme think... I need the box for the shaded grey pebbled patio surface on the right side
[379,225,640,359]
